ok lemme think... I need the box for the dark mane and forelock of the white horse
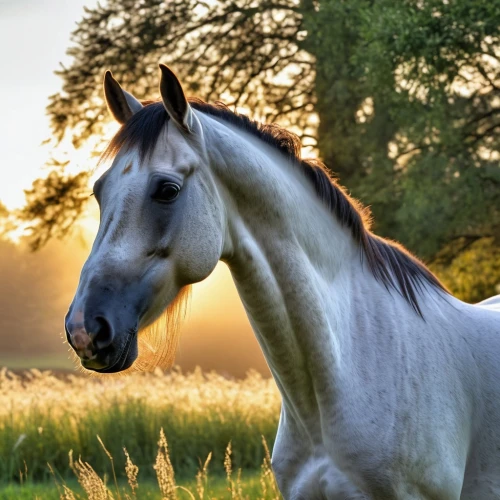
[103,99,446,316]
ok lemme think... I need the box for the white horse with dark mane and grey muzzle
[66,65,500,500]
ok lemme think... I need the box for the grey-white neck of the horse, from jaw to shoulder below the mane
[203,115,378,428]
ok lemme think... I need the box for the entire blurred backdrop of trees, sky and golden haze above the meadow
[0,0,500,376]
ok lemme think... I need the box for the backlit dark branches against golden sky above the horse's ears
[48,0,314,146]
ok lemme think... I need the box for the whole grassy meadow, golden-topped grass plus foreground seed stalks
[0,369,280,500]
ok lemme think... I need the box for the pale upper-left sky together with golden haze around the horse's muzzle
[0,0,268,376]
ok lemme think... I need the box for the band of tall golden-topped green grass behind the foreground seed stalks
[0,370,280,482]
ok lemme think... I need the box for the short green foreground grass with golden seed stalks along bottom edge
[0,430,282,500]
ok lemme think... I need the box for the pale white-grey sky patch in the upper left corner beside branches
[0,0,100,208]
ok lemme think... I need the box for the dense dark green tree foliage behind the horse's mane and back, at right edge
[298,0,500,294]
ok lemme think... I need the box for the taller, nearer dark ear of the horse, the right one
[159,64,191,132]
